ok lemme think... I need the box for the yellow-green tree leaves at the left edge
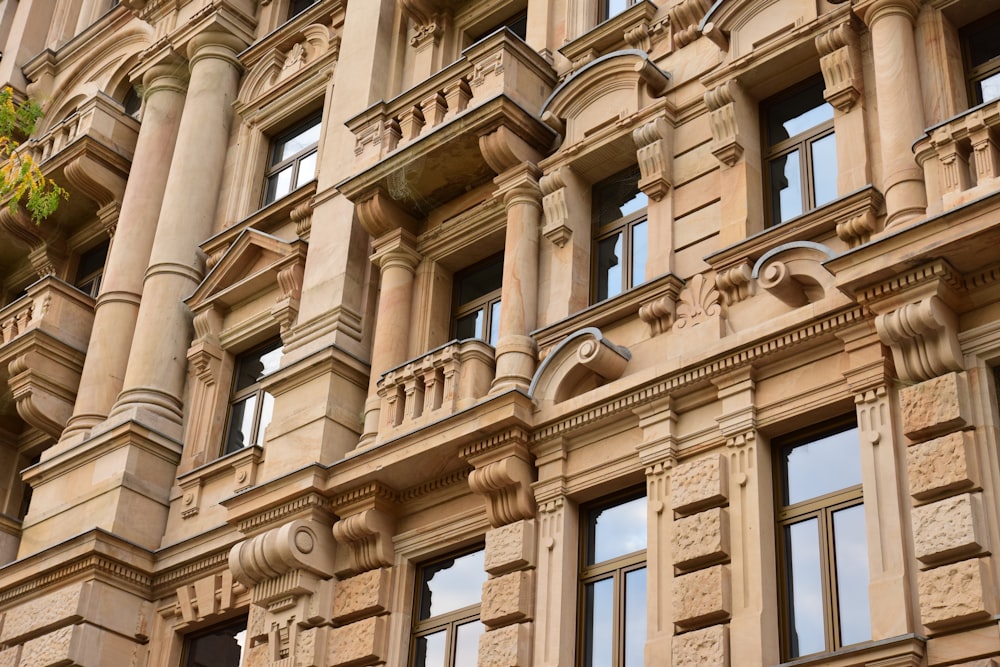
[0,87,68,223]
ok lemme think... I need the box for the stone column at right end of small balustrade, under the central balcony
[492,162,542,392]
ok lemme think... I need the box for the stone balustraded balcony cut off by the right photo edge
[914,100,1000,215]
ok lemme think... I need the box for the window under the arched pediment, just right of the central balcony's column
[592,165,649,303]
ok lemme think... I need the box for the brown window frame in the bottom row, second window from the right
[575,486,649,667]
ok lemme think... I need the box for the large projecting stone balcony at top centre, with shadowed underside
[338,29,556,218]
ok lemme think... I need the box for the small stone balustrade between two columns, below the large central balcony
[378,339,495,440]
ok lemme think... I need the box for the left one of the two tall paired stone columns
[60,60,186,448]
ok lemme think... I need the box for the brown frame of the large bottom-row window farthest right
[771,414,871,661]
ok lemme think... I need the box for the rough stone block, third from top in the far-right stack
[911,493,986,565]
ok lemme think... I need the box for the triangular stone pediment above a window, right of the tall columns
[186,229,307,312]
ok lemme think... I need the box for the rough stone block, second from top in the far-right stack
[906,431,978,500]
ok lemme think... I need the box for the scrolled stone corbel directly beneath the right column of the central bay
[461,429,535,528]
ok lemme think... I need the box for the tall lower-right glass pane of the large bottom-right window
[833,505,871,646]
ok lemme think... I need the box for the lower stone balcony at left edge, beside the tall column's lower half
[0,276,94,439]
